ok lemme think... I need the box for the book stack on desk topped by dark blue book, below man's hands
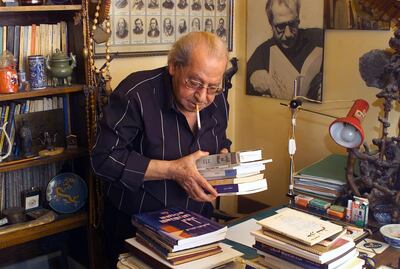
[127,208,241,268]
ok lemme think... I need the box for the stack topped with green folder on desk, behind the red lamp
[294,154,347,203]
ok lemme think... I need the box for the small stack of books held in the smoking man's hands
[196,149,272,196]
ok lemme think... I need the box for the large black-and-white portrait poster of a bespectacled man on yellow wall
[246,0,324,101]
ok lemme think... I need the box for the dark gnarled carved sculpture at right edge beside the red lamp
[347,29,400,223]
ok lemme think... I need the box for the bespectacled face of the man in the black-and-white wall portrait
[272,1,299,49]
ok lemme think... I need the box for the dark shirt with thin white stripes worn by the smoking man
[91,67,231,216]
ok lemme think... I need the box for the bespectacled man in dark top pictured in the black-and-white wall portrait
[246,0,323,100]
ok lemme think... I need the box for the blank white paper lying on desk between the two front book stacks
[226,219,260,247]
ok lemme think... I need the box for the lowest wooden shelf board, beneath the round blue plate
[0,212,88,249]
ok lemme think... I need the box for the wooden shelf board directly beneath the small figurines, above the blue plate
[0,148,88,173]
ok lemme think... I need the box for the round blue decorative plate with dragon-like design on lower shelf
[46,173,87,213]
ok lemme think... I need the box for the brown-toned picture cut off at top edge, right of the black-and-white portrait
[325,0,390,30]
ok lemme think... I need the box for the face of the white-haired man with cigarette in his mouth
[168,48,226,112]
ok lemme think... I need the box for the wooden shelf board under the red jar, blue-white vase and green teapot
[0,85,83,102]
